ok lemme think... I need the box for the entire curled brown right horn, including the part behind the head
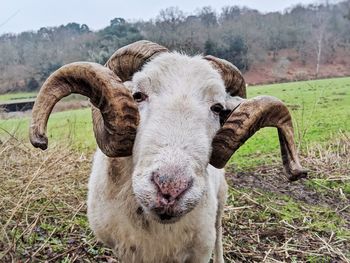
[204,56,307,181]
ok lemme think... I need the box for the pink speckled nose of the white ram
[152,173,193,205]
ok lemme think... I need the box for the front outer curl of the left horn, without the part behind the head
[30,62,139,157]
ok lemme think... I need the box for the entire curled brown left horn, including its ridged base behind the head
[30,41,167,157]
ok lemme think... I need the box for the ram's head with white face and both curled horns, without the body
[30,41,306,222]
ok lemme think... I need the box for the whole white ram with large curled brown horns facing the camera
[30,41,306,262]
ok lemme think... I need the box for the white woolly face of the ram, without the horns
[129,53,226,223]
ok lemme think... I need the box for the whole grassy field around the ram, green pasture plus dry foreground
[0,78,350,262]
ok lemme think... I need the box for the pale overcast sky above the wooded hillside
[0,0,330,34]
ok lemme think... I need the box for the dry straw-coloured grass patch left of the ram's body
[0,137,115,262]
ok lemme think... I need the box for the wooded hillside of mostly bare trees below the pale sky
[0,0,350,93]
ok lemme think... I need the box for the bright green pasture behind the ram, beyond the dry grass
[0,78,350,168]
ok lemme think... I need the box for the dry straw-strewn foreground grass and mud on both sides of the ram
[0,134,350,262]
